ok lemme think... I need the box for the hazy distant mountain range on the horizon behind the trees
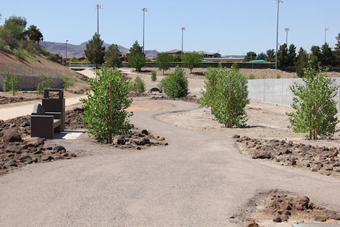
[40,41,127,57]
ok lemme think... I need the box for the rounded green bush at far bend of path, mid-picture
[158,66,189,98]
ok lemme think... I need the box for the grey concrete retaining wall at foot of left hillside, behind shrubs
[0,74,63,91]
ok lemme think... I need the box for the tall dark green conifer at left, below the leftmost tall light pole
[84,33,105,69]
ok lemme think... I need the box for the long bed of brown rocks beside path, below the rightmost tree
[233,135,340,176]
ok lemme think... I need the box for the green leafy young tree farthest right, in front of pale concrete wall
[286,67,340,140]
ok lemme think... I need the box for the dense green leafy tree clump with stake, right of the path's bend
[202,67,249,128]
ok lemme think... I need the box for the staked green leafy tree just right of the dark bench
[80,67,133,142]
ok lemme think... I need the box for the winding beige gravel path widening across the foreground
[0,98,340,226]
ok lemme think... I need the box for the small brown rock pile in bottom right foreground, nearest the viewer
[261,194,340,223]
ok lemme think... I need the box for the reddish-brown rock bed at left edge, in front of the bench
[0,136,77,175]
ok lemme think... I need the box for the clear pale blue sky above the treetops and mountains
[0,0,340,55]
